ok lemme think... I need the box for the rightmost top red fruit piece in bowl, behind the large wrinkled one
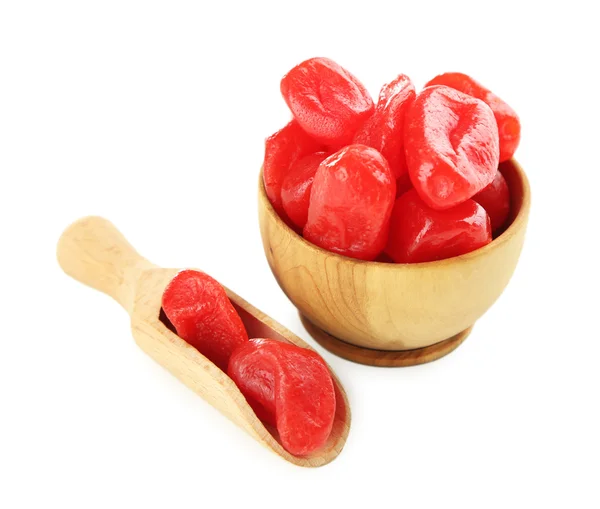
[425,72,521,162]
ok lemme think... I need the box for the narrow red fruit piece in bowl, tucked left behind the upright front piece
[281,152,328,229]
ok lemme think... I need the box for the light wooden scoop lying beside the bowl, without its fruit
[57,217,350,467]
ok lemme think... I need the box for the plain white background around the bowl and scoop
[0,0,600,509]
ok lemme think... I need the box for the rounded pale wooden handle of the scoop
[56,216,154,314]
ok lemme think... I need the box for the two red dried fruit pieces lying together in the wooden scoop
[162,270,336,456]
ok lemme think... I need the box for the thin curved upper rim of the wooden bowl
[258,158,531,269]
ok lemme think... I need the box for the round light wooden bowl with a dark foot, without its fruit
[259,159,531,366]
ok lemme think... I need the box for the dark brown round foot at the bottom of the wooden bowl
[300,313,473,367]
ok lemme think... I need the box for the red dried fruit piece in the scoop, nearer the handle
[162,270,248,371]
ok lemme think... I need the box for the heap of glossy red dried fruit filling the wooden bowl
[263,58,521,263]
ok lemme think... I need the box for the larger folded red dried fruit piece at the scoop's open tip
[227,339,336,456]
